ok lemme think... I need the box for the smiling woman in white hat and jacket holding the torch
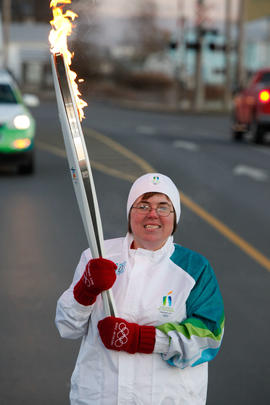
[56,173,224,405]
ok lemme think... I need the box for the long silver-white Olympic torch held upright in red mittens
[51,0,117,316]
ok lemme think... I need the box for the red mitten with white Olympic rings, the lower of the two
[98,316,156,354]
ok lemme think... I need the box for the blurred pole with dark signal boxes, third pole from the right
[194,0,204,111]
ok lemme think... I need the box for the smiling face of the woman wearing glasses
[130,194,175,250]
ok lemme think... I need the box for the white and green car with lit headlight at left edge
[0,70,38,174]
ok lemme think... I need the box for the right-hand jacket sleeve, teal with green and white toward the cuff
[157,248,224,368]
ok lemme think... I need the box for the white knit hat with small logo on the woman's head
[127,173,181,222]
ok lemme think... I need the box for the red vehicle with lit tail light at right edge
[232,68,270,143]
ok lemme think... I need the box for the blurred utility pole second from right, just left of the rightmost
[224,0,232,110]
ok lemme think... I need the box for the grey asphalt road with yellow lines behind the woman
[0,101,270,405]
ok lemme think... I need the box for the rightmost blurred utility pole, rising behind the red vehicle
[236,0,245,87]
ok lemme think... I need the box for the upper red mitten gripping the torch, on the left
[73,257,117,305]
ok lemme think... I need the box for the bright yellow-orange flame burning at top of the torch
[49,0,87,121]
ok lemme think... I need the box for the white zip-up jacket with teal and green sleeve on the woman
[56,234,224,405]
